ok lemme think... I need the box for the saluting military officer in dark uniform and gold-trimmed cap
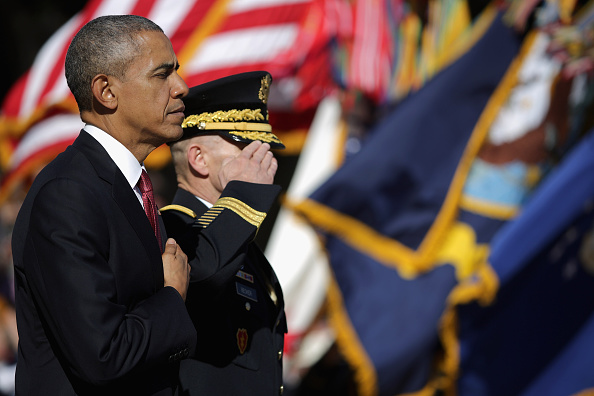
[161,72,287,396]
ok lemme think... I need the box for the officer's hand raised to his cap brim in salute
[219,140,278,186]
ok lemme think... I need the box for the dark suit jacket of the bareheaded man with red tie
[12,131,196,396]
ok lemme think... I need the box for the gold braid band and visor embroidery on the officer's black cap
[182,109,282,144]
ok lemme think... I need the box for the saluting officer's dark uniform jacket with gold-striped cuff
[162,181,287,396]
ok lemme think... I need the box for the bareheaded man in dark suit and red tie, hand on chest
[12,15,196,396]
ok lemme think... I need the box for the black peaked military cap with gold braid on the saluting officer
[181,71,285,149]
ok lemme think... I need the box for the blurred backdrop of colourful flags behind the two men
[0,0,594,396]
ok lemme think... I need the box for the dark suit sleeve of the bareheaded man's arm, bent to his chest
[24,179,196,384]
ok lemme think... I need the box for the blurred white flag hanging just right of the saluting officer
[265,97,343,385]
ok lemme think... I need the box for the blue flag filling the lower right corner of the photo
[446,130,594,396]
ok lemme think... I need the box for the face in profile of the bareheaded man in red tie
[117,31,188,147]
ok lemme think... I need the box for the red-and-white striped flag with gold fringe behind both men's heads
[0,0,334,202]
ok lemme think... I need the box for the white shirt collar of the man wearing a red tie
[83,124,144,188]
